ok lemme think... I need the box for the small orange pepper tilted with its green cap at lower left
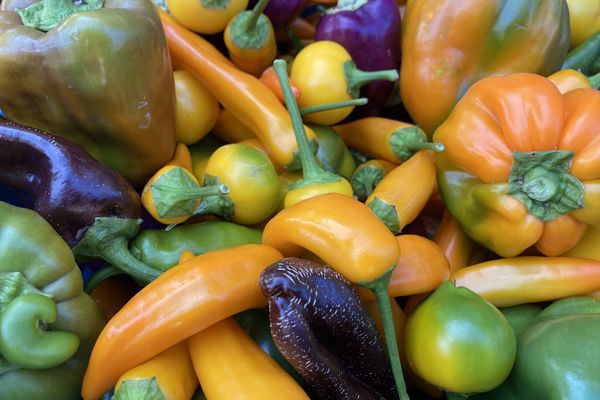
[365,150,436,234]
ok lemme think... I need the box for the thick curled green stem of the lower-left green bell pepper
[0,293,79,369]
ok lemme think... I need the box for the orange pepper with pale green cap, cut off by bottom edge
[111,341,198,400]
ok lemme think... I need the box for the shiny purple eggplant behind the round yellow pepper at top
[315,0,401,116]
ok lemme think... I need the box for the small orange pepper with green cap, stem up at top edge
[224,0,277,76]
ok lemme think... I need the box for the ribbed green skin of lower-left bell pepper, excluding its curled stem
[0,202,104,400]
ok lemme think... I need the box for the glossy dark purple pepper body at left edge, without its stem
[0,119,141,246]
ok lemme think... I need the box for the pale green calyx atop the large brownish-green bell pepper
[16,0,104,32]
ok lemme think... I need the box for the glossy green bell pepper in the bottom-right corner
[473,297,600,400]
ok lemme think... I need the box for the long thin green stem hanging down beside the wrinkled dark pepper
[357,266,410,400]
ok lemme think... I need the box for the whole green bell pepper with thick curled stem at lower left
[0,202,104,400]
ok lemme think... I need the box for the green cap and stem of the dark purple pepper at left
[73,217,162,283]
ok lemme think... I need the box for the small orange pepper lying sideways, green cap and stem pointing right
[332,117,444,164]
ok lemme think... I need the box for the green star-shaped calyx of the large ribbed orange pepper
[508,150,585,222]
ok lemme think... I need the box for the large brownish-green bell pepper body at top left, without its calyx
[0,0,175,186]
